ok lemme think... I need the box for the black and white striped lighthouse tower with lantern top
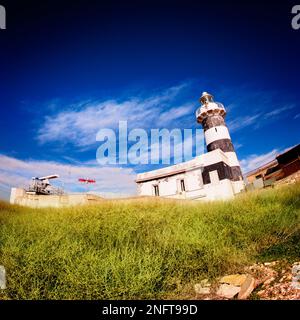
[196,92,243,181]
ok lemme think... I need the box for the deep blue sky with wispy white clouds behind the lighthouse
[0,1,300,198]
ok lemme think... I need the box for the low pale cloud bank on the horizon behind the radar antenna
[0,154,136,200]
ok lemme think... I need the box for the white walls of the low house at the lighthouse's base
[137,149,245,200]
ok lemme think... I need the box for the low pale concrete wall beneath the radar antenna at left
[10,188,103,208]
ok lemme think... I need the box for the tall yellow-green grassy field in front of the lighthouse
[0,184,300,299]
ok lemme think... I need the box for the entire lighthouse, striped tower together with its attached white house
[136,92,244,200]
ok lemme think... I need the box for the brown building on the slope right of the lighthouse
[246,144,300,187]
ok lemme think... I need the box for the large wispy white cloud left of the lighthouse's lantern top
[37,84,193,147]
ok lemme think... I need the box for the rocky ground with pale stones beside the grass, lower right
[194,261,300,300]
